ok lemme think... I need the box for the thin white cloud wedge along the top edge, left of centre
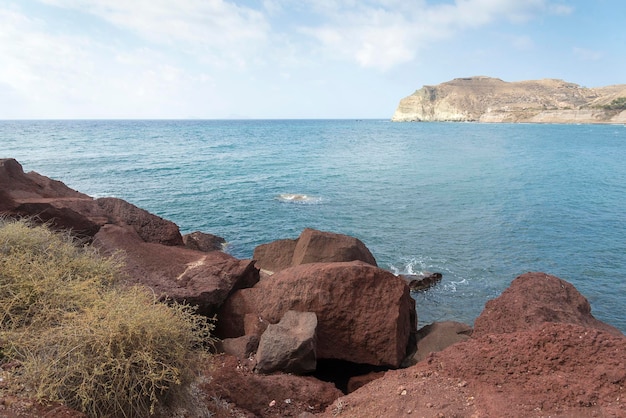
[40,0,270,66]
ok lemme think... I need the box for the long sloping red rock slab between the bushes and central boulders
[93,225,259,314]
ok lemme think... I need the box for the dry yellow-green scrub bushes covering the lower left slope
[0,221,212,417]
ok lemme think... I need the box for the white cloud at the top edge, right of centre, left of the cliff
[294,0,566,70]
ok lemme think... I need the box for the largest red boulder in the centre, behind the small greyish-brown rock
[218,261,417,367]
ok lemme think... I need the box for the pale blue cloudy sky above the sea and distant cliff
[0,0,626,119]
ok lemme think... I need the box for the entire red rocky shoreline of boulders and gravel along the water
[0,159,626,417]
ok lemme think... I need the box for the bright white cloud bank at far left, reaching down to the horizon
[0,5,219,118]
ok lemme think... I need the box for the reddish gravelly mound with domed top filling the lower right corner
[322,273,626,417]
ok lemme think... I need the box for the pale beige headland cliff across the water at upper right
[392,76,626,123]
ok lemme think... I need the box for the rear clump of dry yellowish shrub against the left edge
[0,220,121,330]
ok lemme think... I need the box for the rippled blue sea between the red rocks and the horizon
[0,120,626,332]
